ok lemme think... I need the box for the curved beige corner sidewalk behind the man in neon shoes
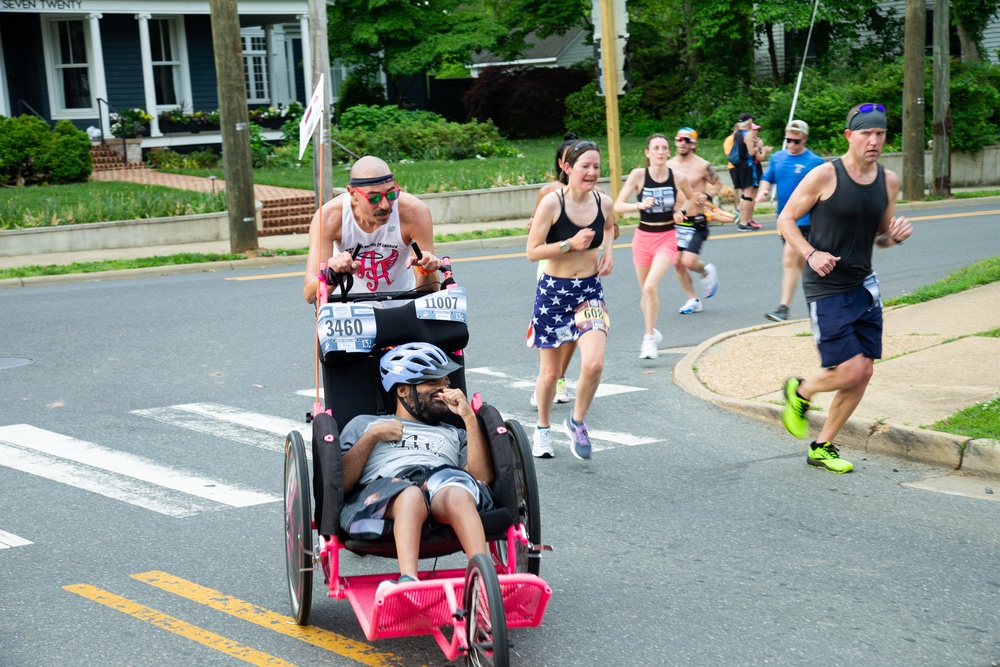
[674,283,1000,478]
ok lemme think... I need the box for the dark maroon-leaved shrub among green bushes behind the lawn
[462,67,594,138]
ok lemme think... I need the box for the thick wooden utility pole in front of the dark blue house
[209,0,257,253]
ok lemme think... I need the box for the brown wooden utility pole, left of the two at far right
[903,0,927,201]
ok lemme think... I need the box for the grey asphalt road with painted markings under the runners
[0,205,1000,667]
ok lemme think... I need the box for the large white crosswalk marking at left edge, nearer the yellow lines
[0,424,281,517]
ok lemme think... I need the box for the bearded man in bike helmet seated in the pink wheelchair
[340,343,494,598]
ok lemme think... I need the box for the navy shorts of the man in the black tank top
[809,285,882,368]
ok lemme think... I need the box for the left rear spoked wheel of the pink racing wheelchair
[285,431,313,625]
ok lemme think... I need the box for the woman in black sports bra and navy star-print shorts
[527,141,614,459]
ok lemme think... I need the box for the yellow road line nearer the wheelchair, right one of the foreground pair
[132,570,402,667]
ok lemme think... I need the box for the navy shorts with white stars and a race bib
[525,274,611,348]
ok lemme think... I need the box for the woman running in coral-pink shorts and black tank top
[615,134,692,359]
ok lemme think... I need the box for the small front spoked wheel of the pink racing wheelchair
[465,554,510,667]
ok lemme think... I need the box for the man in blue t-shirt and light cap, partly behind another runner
[757,120,824,322]
